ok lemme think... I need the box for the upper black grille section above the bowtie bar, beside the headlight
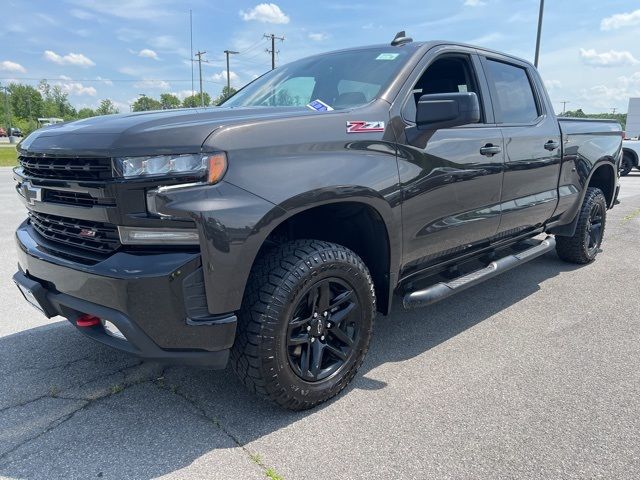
[18,156,113,181]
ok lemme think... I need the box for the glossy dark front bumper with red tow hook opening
[14,222,236,368]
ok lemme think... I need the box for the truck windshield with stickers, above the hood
[222,47,409,110]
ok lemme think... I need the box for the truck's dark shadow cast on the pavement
[0,254,576,478]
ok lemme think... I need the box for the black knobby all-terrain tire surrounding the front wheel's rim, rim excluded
[231,240,376,410]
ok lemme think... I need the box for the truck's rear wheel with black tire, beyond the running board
[556,187,607,264]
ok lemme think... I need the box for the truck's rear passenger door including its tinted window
[481,55,561,235]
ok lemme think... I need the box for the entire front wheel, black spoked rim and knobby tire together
[231,240,376,410]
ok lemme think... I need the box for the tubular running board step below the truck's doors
[402,237,556,308]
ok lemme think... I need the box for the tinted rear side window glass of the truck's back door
[486,59,540,123]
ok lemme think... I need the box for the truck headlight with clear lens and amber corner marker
[113,153,227,183]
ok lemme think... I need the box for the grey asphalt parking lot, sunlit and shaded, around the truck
[0,169,640,480]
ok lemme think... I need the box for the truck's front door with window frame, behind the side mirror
[391,47,503,275]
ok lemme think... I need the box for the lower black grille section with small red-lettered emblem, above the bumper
[29,211,120,256]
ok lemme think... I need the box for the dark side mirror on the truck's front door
[416,92,480,130]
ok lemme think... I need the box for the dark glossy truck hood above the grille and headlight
[19,107,323,156]
